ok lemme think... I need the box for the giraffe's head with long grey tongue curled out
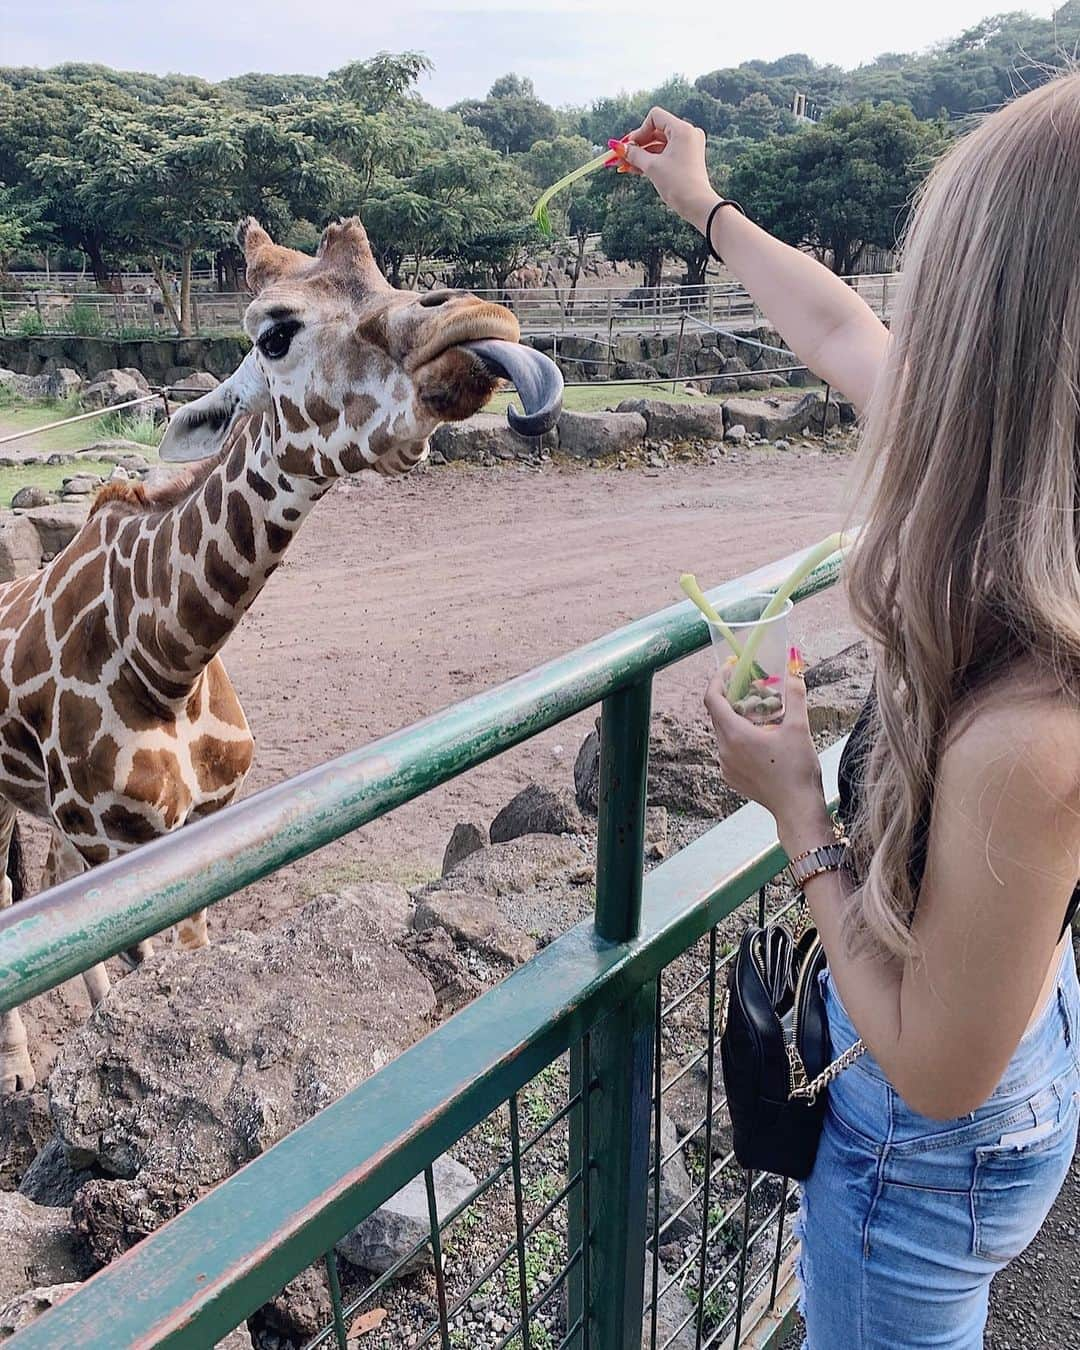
[161,217,562,478]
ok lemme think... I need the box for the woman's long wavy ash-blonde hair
[848,73,1080,954]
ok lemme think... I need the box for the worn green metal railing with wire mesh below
[0,537,838,1350]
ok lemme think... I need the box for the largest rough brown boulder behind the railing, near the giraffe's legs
[49,892,435,1184]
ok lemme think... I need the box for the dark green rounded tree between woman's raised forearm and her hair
[728,104,945,274]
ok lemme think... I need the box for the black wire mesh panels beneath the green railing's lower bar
[274,869,798,1350]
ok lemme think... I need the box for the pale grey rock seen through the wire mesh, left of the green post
[338,1154,477,1274]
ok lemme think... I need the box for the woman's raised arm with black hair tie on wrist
[626,108,888,409]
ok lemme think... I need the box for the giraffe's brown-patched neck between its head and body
[107,409,333,703]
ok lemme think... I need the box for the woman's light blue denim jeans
[799,942,1080,1350]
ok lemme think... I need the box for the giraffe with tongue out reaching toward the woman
[0,219,562,1094]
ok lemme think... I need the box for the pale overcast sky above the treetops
[0,0,1056,105]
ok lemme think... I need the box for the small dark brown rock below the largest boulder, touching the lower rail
[72,1173,205,1269]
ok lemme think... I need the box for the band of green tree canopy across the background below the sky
[0,0,1080,321]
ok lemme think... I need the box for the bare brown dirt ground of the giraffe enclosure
[18,450,1080,1350]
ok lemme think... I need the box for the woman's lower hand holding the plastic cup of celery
[705,656,830,852]
